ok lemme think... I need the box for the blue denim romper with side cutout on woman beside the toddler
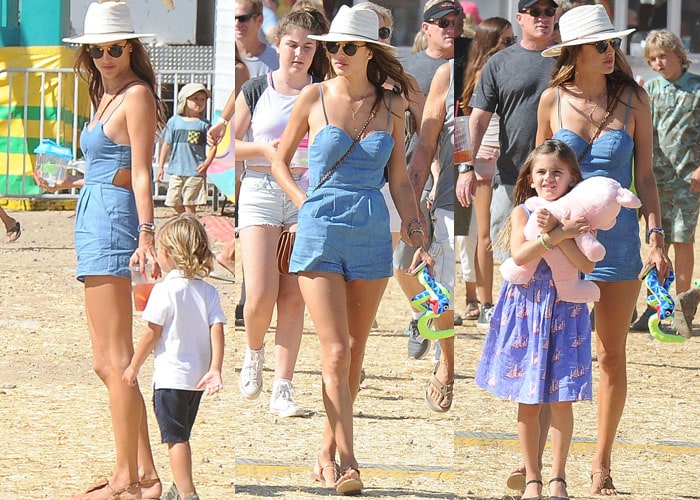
[75,106,139,281]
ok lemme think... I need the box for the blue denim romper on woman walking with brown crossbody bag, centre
[289,86,394,281]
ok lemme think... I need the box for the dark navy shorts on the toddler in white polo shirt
[153,389,204,443]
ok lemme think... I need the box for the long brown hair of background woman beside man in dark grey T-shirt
[461,17,511,115]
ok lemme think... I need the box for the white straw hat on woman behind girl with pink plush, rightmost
[542,5,634,57]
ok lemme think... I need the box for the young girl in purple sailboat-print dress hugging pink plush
[475,140,594,500]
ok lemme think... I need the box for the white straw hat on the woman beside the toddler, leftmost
[63,0,154,45]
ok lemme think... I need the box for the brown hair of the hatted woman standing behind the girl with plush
[549,45,641,109]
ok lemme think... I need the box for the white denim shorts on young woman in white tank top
[238,170,302,230]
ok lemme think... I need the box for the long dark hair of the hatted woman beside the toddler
[73,38,167,129]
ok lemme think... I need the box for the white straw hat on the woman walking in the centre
[308,4,396,50]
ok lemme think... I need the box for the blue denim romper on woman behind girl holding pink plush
[552,89,642,281]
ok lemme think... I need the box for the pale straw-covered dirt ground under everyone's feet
[0,204,700,500]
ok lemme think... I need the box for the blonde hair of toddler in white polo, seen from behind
[157,214,214,279]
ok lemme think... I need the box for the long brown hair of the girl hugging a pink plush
[494,139,583,250]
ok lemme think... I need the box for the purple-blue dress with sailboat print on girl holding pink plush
[475,259,591,404]
